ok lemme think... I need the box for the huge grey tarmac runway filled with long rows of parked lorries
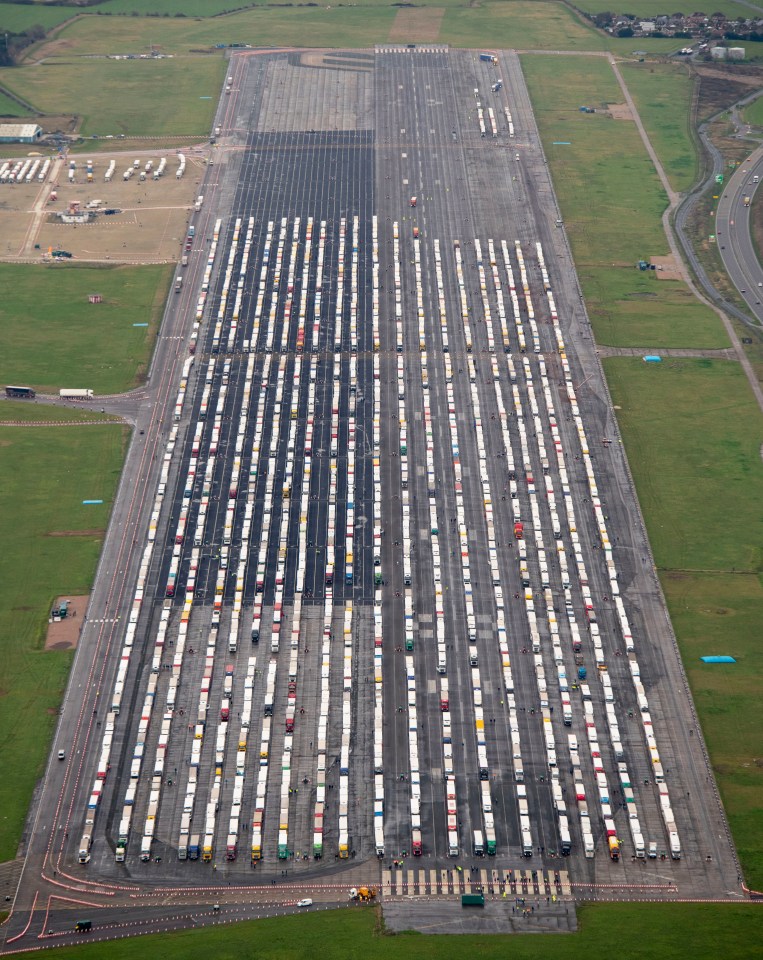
[4,47,739,950]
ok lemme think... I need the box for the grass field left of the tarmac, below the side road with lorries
[0,424,127,861]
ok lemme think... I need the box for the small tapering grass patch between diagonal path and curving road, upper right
[620,62,698,192]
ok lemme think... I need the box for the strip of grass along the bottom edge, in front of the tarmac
[37,903,763,960]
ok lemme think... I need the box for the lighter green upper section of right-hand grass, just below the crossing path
[605,357,763,576]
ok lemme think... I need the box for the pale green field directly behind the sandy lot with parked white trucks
[0,56,225,136]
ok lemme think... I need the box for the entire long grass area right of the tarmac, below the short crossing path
[604,358,763,888]
